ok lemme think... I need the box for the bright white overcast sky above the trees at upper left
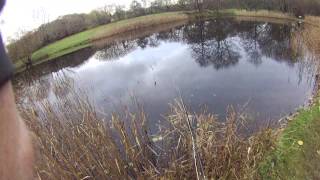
[0,0,131,42]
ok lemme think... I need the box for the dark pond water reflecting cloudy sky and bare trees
[17,18,315,133]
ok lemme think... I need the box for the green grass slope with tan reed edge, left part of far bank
[15,12,188,71]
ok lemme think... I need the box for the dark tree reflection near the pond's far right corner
[229,19,301,66]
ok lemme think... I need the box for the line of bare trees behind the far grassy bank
[7,0,320,61]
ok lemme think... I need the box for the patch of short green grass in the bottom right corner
[260,99,320,180]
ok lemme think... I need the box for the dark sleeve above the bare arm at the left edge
[0,36,14,87]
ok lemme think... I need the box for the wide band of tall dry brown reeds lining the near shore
[20,80,275,179]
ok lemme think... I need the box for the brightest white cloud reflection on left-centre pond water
[69,43,186,107]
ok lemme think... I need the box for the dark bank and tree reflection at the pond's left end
[13,48,95,102]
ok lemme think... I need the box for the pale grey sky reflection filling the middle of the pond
[58,38,311,129]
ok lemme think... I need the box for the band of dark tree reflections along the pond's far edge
[89,19,296,69]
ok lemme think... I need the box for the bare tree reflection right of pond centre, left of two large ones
[184,21,240,69]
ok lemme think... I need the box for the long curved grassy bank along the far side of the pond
[15,9,295,71]
